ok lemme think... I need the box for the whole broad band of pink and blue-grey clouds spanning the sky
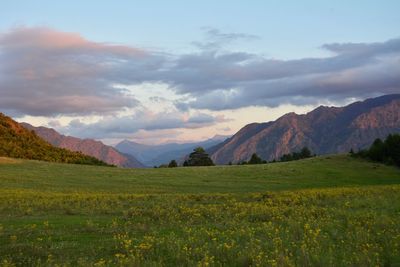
[0,28,400,118]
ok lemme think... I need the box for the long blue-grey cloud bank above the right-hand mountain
[168,39,400,110]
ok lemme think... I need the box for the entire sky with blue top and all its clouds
[0,0,400,144]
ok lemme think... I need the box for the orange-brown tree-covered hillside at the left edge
[0,113,108,165]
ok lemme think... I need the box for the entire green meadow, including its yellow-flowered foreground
[0,156,400,266]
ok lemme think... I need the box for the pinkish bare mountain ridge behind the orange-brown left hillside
[21,123,144,168]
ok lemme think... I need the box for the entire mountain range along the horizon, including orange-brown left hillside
[0,94,400,168]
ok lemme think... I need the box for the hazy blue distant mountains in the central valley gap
[115,135,228,166]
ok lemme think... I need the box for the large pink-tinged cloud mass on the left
[0,27,161,116]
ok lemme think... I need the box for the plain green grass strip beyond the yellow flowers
[0,155,400,194]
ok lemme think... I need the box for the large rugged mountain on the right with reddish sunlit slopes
[207,94,400,164]
